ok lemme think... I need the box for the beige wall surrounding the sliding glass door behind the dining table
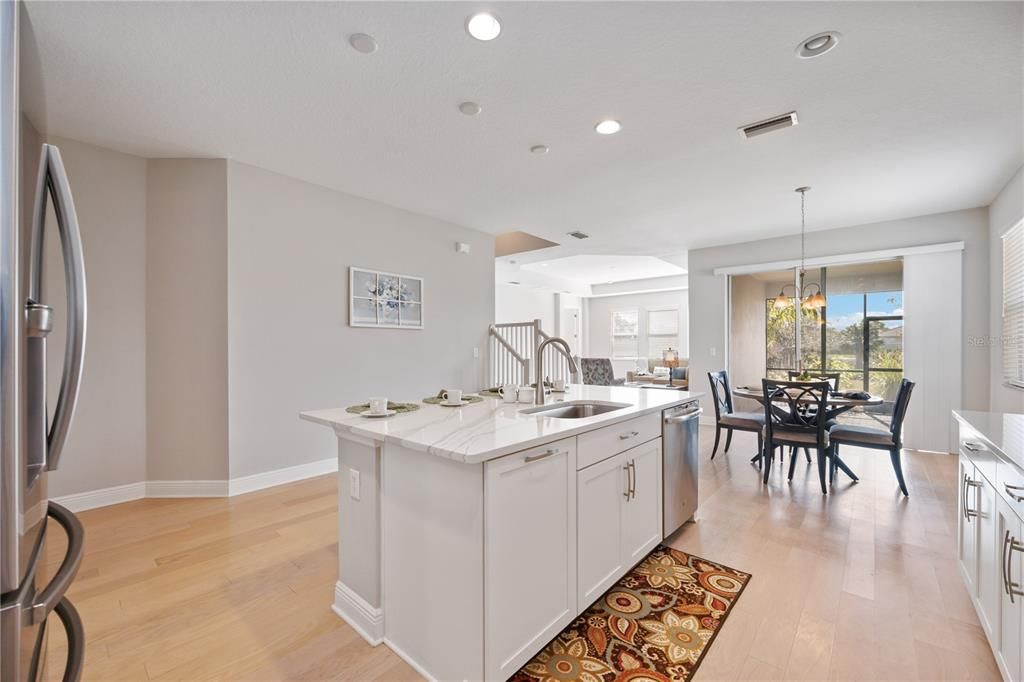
[688,208,989,419]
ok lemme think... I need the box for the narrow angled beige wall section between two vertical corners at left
[144,159,228,480]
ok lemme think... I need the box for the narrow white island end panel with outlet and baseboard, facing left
[334,435,384,645]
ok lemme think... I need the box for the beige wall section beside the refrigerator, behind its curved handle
[34,135,146,496]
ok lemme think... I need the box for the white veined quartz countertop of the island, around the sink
[300,386,702,464]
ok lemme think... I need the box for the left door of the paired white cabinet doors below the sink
[577,453,629,610]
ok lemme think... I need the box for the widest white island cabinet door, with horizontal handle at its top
[483,438,578,680]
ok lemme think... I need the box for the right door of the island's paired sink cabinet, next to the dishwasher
[622,438,662,568]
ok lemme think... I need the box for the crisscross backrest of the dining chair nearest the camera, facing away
[761,379,829,446]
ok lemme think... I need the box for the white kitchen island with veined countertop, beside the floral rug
[301,386,699,680]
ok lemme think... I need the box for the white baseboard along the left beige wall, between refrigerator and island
[53,457,338,512]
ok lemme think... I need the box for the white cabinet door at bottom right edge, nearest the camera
[992,498,1024,682]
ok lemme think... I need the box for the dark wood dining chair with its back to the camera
[761,379,830,495]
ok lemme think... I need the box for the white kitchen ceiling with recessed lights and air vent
[23,2,1024,261]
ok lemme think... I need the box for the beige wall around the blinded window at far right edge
[986,168,1024,413]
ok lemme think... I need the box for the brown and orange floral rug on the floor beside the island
[511,545,751,682]
